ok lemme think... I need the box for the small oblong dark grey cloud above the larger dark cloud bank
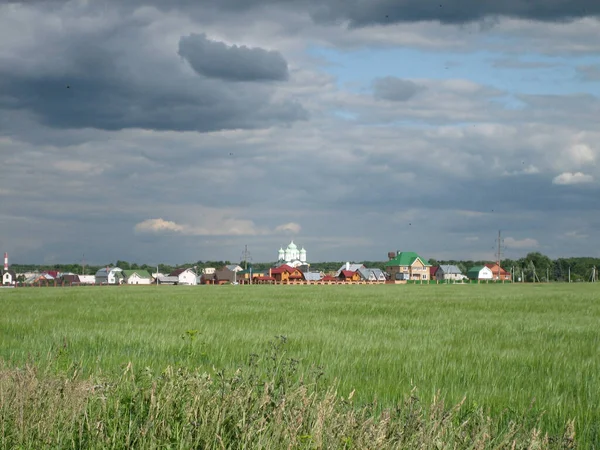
[179,34,288,81]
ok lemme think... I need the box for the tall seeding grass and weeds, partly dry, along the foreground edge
[0,340,575,449]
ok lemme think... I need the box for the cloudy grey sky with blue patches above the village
[0,0,600,264]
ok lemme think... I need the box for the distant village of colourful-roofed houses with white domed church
[2,241,512,286]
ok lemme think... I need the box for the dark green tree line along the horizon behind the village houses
[11,252,600,282]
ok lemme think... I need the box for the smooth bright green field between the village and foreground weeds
[0,284,600,448]
